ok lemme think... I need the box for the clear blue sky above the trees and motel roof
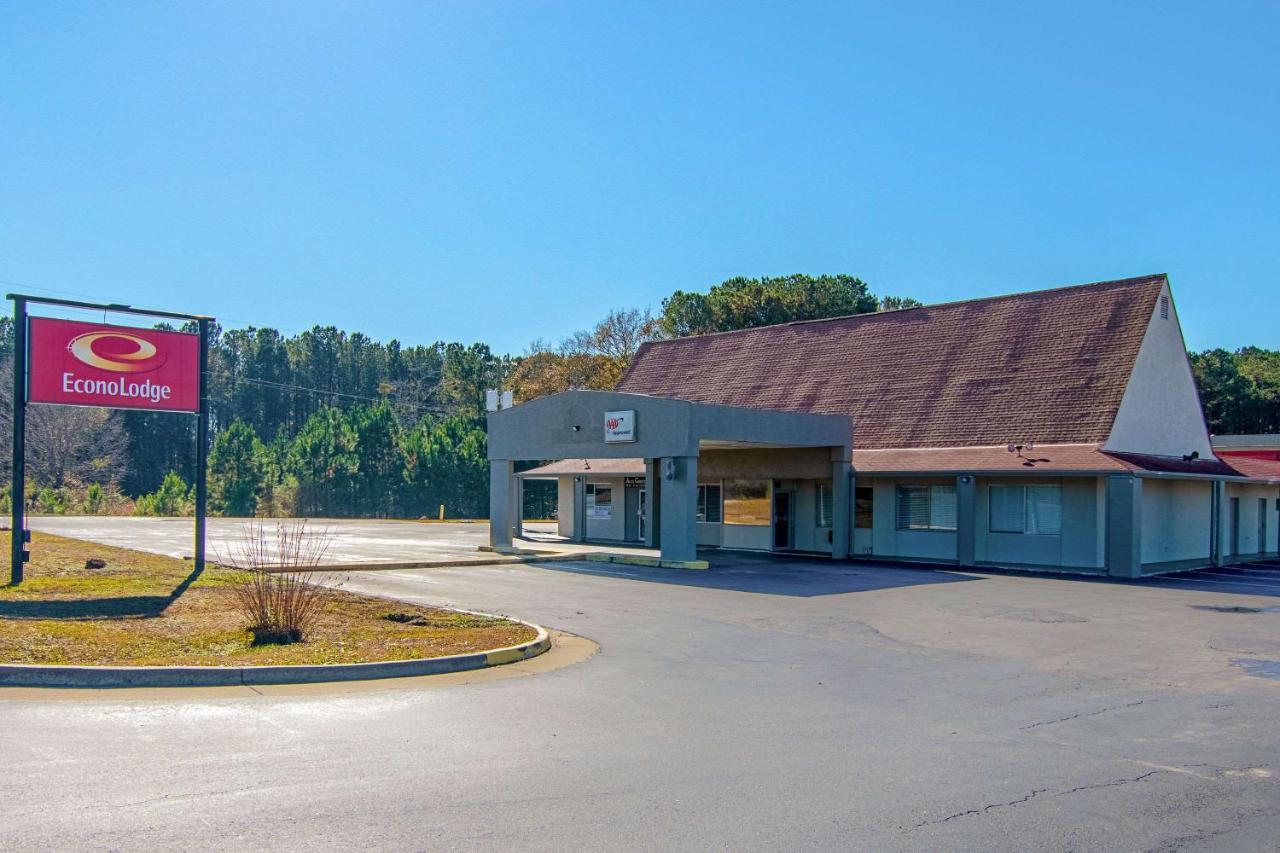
[0,0,1280,352]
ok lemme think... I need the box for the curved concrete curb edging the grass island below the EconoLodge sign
[0,611,552,688]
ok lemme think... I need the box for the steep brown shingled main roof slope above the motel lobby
[617,274,1166,448]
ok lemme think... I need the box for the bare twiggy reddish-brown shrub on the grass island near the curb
[228,519,333,646]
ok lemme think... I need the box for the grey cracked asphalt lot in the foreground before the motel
[0,522,1280,850]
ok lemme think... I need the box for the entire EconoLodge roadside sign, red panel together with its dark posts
[8,293,214,584]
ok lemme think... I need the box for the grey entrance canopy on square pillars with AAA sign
[489,391,854,561]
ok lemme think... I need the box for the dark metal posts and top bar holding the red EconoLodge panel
[6,293,214,585]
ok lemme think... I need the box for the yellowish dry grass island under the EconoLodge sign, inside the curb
[0,532,536,666]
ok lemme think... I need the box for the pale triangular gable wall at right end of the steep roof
[1105,284,1213,459]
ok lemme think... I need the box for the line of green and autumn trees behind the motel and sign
[0,274,1280,517]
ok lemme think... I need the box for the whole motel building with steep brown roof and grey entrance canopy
[489,275,1280,578]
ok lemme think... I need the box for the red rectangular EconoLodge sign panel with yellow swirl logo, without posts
[27,316,200,412]
